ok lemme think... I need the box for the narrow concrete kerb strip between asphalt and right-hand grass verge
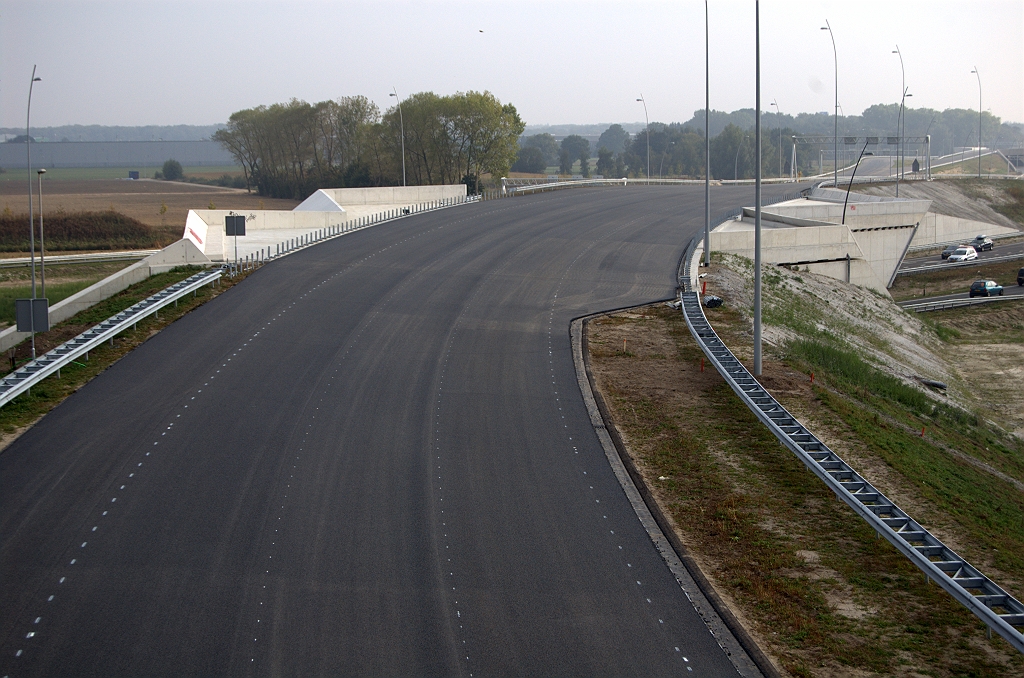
[570,319,763,678]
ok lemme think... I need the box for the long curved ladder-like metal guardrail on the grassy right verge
[679,238,1024,652]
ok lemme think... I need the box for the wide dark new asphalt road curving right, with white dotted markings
[0,186,795,677]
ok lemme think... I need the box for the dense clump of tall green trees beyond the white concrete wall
[213,91,525,199]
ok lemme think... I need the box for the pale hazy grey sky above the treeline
[0,0,1024,127]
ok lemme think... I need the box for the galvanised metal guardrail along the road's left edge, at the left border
[0,268,224,407]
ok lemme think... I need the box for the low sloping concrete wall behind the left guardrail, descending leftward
[0,240,210,351]
